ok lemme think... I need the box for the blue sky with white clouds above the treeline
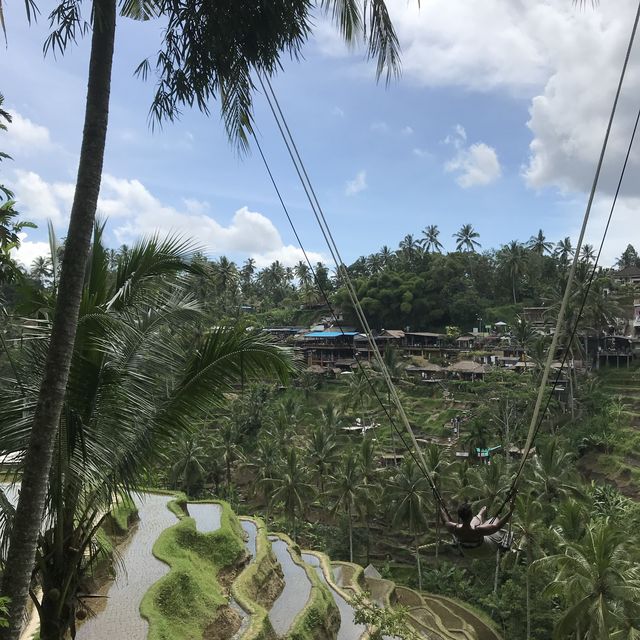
[0,0,640,266]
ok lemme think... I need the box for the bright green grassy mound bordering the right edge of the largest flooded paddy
[140,503,245,640]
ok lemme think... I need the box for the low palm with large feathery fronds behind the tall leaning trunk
[0,226,291,640]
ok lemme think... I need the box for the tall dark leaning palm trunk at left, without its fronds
[0,0,116,640]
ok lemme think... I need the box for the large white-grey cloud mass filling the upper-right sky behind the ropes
[317,0,640,195]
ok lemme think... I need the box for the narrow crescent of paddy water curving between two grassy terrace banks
[269,537,311,636]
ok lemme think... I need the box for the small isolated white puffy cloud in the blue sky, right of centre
[444,124,502,189]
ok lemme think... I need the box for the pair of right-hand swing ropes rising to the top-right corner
[498,3,640,513]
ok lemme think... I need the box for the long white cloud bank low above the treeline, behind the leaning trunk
[10,172,324,265]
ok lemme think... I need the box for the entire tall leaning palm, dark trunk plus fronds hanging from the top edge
[0,0,399,640]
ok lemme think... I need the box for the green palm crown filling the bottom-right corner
[534,520,640,640]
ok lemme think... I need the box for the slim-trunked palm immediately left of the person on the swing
[386,458,431,590]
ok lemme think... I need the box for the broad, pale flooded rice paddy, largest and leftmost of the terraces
[76,494,176,640]
